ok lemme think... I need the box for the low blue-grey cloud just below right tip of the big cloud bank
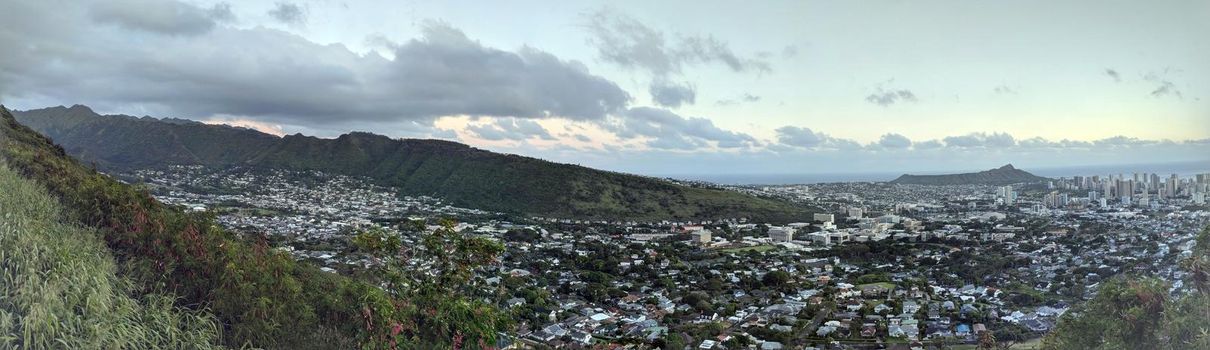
[601,107,756,150]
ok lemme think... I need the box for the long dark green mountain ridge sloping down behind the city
[15,105,808,222]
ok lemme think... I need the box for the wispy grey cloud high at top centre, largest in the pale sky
[584,10,772,78]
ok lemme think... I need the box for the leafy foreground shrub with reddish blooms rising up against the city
[353,219,511,348]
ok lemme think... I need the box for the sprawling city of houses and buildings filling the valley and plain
[122,166,1210,349]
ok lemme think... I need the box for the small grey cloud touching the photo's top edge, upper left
[89,0,235,35]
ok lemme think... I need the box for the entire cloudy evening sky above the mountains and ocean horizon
[0,0,1210,176]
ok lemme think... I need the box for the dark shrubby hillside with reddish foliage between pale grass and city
[0,107,496,349]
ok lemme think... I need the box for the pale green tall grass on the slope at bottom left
[0,162,220,349]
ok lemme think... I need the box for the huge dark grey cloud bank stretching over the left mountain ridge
[0,1,630,127]
